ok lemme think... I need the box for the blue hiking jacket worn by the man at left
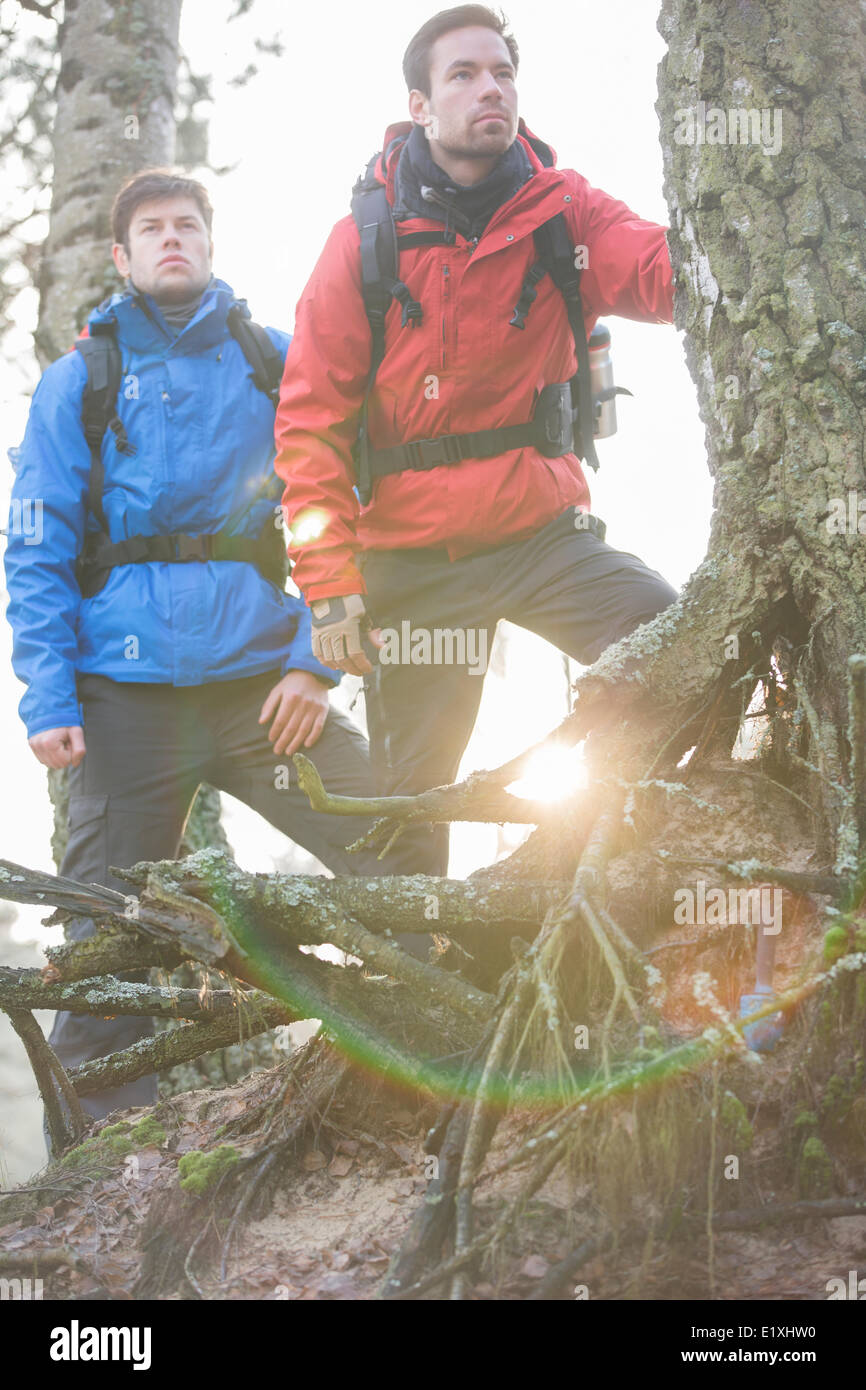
[6,279,339,738]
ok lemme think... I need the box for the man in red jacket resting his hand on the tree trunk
[275,4,676,874]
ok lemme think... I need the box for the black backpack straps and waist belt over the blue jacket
[75,304,289,598]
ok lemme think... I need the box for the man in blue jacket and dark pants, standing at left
[6,170,381,1116]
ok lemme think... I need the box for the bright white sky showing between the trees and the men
[0,0,712,934]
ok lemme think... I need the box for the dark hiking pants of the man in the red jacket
[361,507,677,874]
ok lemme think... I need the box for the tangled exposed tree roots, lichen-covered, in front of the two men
[0,633,866,1300]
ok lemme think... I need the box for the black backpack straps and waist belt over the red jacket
[352,140,627,506]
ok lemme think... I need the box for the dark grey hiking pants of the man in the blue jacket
[50,671,386,1119]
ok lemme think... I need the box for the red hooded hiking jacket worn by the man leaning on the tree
[275,121,673,603]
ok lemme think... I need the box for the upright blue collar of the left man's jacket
[88,277,250,354]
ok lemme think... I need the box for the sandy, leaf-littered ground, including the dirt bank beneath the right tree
[0,766,866,1301]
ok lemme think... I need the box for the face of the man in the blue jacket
[111,197,214,304]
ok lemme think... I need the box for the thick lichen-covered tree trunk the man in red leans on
[656,0,866,872]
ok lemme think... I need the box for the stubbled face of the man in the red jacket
[409,25,517,183]
